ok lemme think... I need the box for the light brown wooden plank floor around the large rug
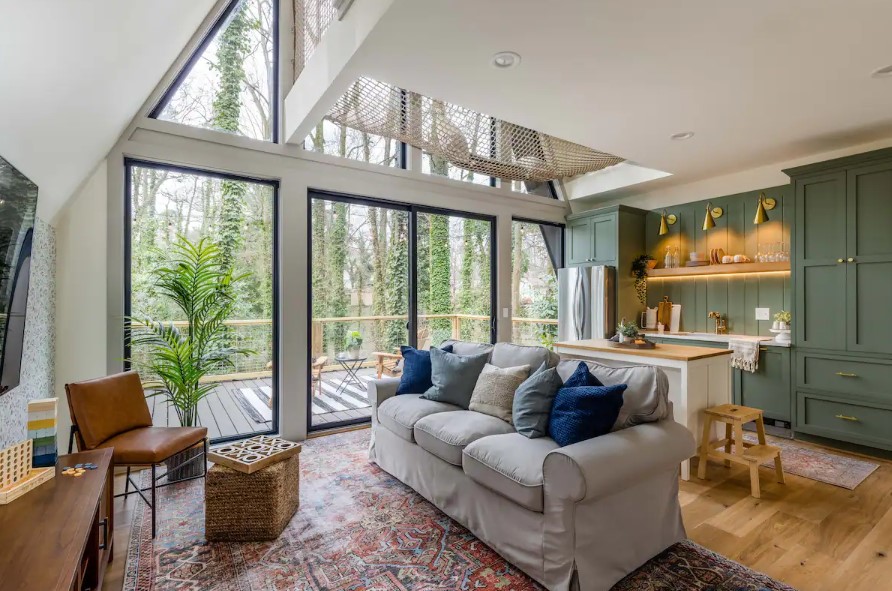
[102,434,892,591]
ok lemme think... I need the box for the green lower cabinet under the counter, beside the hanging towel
[733,347,793,421]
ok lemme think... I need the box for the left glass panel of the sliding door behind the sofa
[309,195,410,429]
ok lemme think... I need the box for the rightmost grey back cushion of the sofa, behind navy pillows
[557,359,671,431]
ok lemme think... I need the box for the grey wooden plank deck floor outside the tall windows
[148,368,375,441]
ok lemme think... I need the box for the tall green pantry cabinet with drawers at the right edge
[785,149,892,449]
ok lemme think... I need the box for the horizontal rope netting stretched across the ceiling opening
[326,78,623,182]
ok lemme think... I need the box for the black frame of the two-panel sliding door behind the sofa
[306,192,499,433]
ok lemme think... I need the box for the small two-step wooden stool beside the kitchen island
[697,404,784,499]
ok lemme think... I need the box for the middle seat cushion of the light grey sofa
[415,410,514,466]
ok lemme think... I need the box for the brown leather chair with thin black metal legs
[65,371,208,538]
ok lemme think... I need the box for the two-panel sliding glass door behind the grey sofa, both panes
[308,193,495,430]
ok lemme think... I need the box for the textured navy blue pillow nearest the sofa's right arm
[548,384,627,447]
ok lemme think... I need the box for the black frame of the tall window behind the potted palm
[123,157,281,444]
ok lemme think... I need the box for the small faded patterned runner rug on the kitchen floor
[743,433,880,490]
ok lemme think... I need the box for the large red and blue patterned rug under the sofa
[124,430,791,591]
